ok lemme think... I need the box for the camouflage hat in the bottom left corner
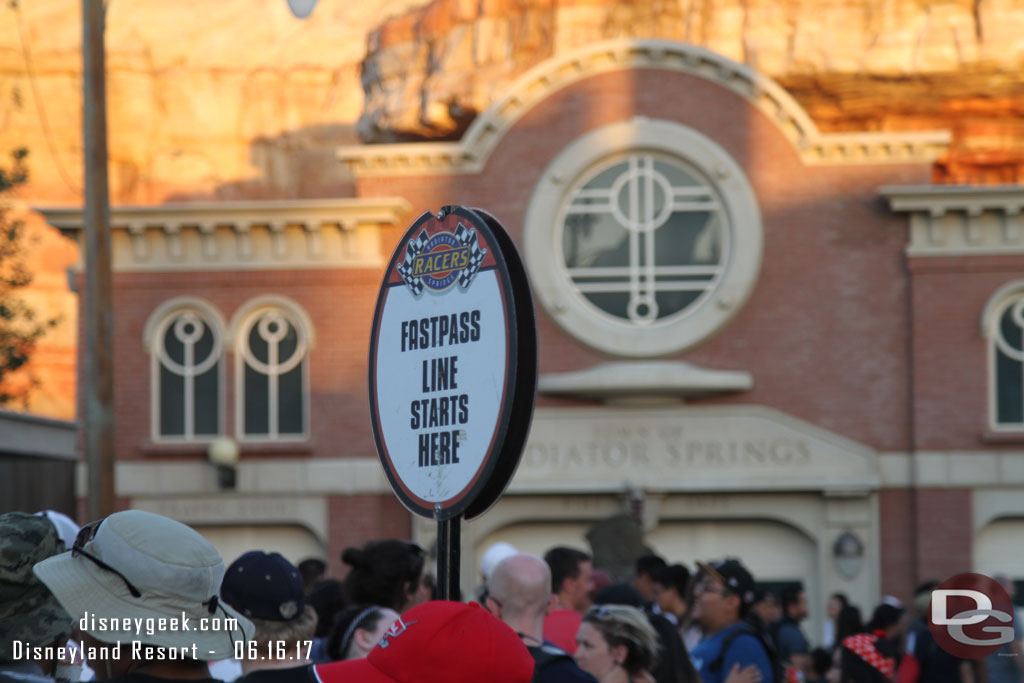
[0,512,72,661]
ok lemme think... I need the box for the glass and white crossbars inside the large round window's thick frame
[557,154,728,326]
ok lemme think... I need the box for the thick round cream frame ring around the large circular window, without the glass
[523,117,763,357]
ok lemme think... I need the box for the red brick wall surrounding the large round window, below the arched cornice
[358,70,929,450]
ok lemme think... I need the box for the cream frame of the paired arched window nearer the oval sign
[231,296,314,443]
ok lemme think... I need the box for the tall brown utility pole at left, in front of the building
[82,0,115,520]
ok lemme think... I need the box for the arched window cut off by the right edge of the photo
[982,283,1024,431]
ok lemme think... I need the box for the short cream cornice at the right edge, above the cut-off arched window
[879,185,1024,257]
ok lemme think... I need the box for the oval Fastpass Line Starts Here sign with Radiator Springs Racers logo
[369,207,537,520]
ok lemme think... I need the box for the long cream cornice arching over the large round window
[338,40,950,176]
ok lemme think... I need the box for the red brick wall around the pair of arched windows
[114,270,380,460]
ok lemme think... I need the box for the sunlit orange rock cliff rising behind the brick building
[0,0,1024,204]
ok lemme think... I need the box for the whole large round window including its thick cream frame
[523,119,762,356]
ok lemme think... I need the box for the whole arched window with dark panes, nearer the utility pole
[143,299,224,441]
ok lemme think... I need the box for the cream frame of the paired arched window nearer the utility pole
[142,297,227,443]
